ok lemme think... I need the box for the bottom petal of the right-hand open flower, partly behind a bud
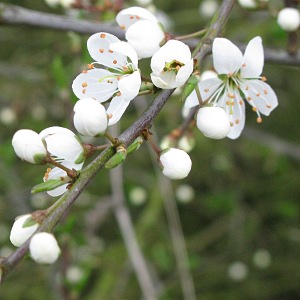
[218,92,246,139]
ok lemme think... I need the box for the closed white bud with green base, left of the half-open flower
[12,129,47,164]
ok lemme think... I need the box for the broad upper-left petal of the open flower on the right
[212,38,243,74]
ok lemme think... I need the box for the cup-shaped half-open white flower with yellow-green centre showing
[151,40,193,89]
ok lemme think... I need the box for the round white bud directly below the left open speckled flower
[74,98,108,136]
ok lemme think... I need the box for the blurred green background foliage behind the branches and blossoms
[0,0,300,300]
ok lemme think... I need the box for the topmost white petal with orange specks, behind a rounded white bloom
[116,6,157,30]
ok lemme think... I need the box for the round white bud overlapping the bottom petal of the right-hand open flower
[197,106,230,139]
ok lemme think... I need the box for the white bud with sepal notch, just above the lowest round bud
[10,214,39,247]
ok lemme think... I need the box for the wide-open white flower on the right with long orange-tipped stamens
[186,37,278,139]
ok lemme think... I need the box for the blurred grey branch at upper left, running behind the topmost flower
[0,3,125,39]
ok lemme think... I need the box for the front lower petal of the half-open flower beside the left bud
[45,133,84,162]
